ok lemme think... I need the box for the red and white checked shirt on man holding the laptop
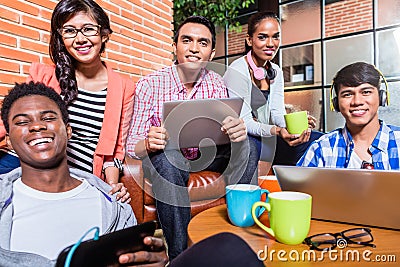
[126,65,228,159]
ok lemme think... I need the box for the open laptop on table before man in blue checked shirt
[273,166,400,230]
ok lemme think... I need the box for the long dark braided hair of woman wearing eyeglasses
[49,0,112,105]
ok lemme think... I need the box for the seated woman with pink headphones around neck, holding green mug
[224,12,321,165]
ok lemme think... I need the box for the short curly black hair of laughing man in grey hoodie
[1,82,68,133]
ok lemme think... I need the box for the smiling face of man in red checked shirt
[173,22,215,65]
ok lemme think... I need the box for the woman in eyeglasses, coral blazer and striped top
[0,0,134,201]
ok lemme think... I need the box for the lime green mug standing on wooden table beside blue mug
[251,191,312,245]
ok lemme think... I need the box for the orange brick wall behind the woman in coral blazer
[0,0,173,96]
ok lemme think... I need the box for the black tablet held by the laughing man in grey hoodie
[56,221,157,267]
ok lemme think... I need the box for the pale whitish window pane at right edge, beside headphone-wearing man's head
[377,28,400,78]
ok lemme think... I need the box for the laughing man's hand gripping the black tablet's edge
[119,236,168,267]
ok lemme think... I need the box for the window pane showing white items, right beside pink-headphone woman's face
[281,43,321,89]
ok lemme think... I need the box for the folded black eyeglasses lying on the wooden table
[304,228,375,251]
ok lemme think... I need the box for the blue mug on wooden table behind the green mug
[225,184,269,227]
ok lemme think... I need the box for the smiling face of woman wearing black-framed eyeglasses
[63,12,108,67]
